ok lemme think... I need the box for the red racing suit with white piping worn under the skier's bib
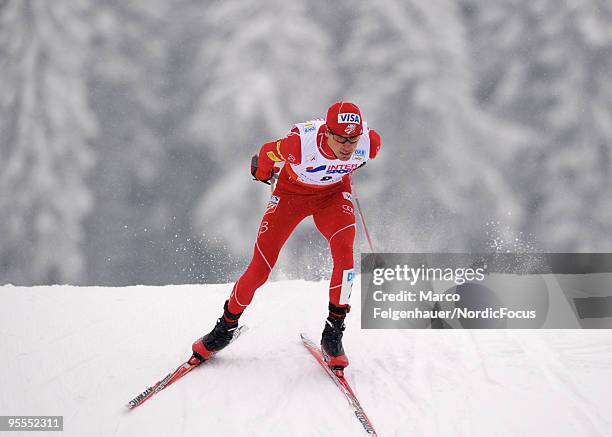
[227,124,381,314]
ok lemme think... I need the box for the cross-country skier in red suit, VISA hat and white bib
[192,102,381,369]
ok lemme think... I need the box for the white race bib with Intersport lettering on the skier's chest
[289,119,370,186]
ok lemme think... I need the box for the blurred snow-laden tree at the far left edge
[0,0,96,285]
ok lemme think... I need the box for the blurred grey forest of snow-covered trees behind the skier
[0,0,612,285]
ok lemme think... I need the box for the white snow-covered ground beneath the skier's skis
[0,279,612,437]
